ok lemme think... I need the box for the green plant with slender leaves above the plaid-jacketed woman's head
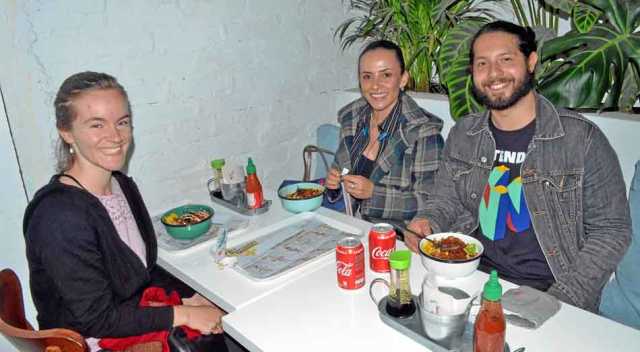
[334,0,497,91]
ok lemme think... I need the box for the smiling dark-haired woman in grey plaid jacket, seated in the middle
[326,40,444,227]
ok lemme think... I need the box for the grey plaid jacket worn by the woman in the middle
[333,93,444,221]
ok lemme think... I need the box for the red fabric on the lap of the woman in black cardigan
[98,287,201,352]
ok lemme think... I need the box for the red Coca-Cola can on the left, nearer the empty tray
[336,237,364,290]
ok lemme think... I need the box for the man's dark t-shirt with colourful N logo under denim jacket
[477,120,554,290]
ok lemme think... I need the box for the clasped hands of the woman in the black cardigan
[173,305,226,335]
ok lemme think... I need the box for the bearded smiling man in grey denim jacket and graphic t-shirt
[406,21,631,311]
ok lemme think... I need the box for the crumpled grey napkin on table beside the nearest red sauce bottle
[502,286,560,329]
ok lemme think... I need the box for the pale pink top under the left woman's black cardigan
[86,178,147,352]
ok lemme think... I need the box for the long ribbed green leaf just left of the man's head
[438,18,488,120]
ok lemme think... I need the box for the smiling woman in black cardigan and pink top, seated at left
[23,72,226,351]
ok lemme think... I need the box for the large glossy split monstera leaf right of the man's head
[538,0,640,110]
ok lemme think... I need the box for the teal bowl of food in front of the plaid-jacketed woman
[278,182,325,213]
